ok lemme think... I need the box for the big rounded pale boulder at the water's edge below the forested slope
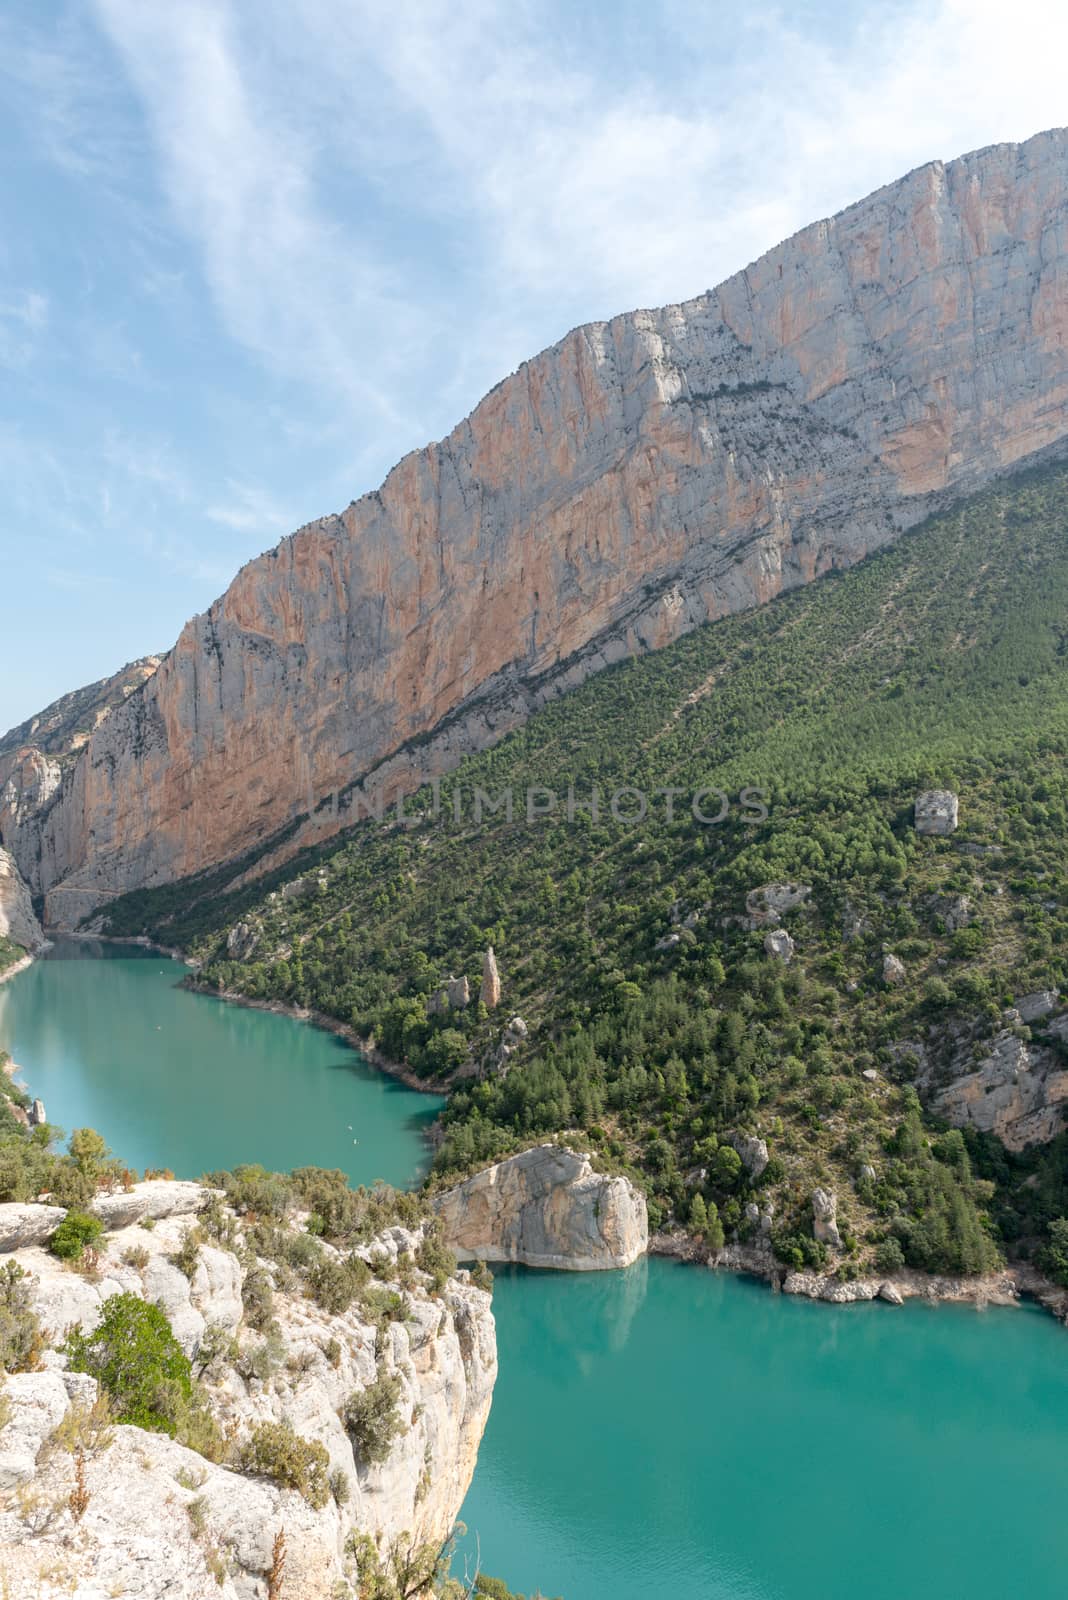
[435,1144,649,1272]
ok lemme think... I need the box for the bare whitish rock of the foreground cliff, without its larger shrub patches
[0,1186,496,1600]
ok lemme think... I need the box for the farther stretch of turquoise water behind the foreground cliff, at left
[0,941,441,1186]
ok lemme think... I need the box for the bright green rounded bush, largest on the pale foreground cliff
[66,1294,193,1438]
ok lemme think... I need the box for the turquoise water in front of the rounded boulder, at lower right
[462,1261,1068,1600]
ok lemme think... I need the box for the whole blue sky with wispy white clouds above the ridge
[0,0,1068,728]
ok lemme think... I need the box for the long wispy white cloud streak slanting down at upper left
[88,0,428,444]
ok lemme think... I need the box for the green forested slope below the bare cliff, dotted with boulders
[102,469,1068,1270]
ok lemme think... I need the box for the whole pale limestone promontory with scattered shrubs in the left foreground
[0,1184,497,1600]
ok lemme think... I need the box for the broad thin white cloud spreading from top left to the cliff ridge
[89,0,1068,456]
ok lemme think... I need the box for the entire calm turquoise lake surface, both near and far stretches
[0,942,1068,1600]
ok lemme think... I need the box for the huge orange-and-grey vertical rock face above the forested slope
[8,131,1068,925]
